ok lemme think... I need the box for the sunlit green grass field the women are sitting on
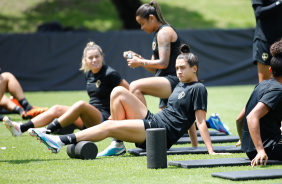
[0,85,282,184]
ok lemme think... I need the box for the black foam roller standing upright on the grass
[146,128,167,169]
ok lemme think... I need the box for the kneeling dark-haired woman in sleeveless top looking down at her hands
[98,0,230,156]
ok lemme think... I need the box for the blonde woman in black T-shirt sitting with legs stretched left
[4,42,129,139]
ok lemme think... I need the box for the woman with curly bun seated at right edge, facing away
[236,40,282,167]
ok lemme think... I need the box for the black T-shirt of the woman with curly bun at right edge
[242,79,282,152]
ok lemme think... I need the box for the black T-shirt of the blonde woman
[86,65,122,119]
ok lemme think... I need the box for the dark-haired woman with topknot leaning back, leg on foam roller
[29,45,221,154]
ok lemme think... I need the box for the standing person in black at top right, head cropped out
[252,0,282,82]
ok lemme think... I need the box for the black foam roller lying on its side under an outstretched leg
[74,141,98,159]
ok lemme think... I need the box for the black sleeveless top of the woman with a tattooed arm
[152,24,181,77]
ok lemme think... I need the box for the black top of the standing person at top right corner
[252,0,282,43]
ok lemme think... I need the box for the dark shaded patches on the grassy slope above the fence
[0,0,215,32]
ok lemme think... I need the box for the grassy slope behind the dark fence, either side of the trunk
[0,0,255,33]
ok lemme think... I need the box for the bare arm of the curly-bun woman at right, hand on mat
[247,102,270,167]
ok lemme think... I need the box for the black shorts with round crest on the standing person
[253,39,272,65]
